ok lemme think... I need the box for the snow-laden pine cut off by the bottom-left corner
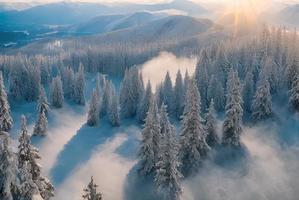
[0,131,18,200]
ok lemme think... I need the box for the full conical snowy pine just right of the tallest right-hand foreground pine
[251,69,273,122]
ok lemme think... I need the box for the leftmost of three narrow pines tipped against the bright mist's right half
[163,72,174,115]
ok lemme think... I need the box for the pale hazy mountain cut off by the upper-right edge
[276,4,299,27]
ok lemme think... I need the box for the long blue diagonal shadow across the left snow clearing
[50,119,141,185]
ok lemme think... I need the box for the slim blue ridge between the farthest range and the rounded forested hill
[68,12,163,34]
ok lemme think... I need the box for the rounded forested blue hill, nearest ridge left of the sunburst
[72,15,215,43]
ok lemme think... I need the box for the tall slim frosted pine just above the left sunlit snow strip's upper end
[74,63,85,106]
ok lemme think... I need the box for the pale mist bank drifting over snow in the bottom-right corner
[183,122,299,200]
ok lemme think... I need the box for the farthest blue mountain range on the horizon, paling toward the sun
[0,0,207,26]
